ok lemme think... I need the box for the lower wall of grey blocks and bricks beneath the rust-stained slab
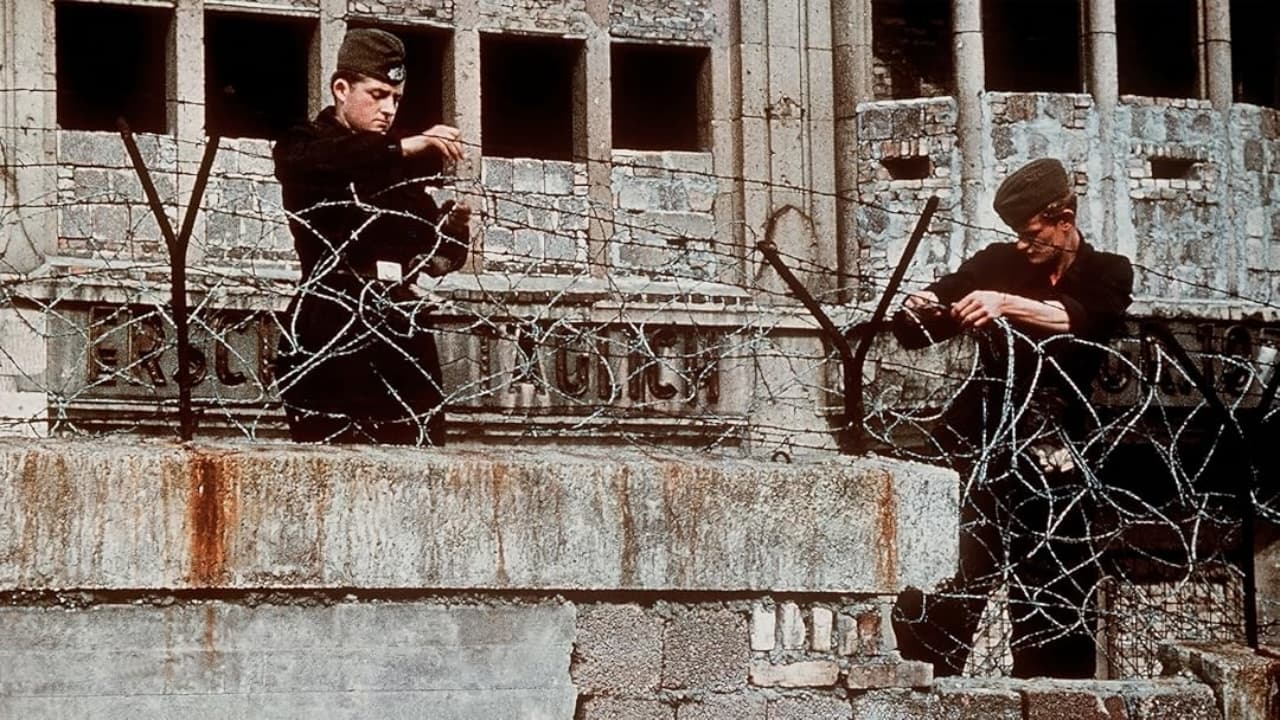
[0,591,1228,720]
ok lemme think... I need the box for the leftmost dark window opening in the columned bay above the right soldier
[872,0,955,100]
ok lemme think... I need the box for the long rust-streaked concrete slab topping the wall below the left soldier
[0,441,957,594]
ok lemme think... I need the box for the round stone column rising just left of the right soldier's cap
[951,0,987,247]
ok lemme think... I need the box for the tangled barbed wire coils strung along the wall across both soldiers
[0,119,1280,676]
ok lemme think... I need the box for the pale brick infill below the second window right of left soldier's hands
[609,151,732,279]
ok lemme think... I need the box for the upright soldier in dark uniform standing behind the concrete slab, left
[274,29,471,445]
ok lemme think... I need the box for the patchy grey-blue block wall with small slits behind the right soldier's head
[858,92,1280,304]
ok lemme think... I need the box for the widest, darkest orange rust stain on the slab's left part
[187,454,238,587]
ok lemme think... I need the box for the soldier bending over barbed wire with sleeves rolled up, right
[895,159,1133,676]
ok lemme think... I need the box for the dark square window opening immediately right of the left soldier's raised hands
[480,35,582,160]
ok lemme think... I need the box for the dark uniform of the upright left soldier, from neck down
[273,108,468,430]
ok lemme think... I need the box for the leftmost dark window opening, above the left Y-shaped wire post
[54,3,173,133]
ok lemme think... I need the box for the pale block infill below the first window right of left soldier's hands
[479,158,596,273]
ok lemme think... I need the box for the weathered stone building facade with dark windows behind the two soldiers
[0,0,1280,450]
